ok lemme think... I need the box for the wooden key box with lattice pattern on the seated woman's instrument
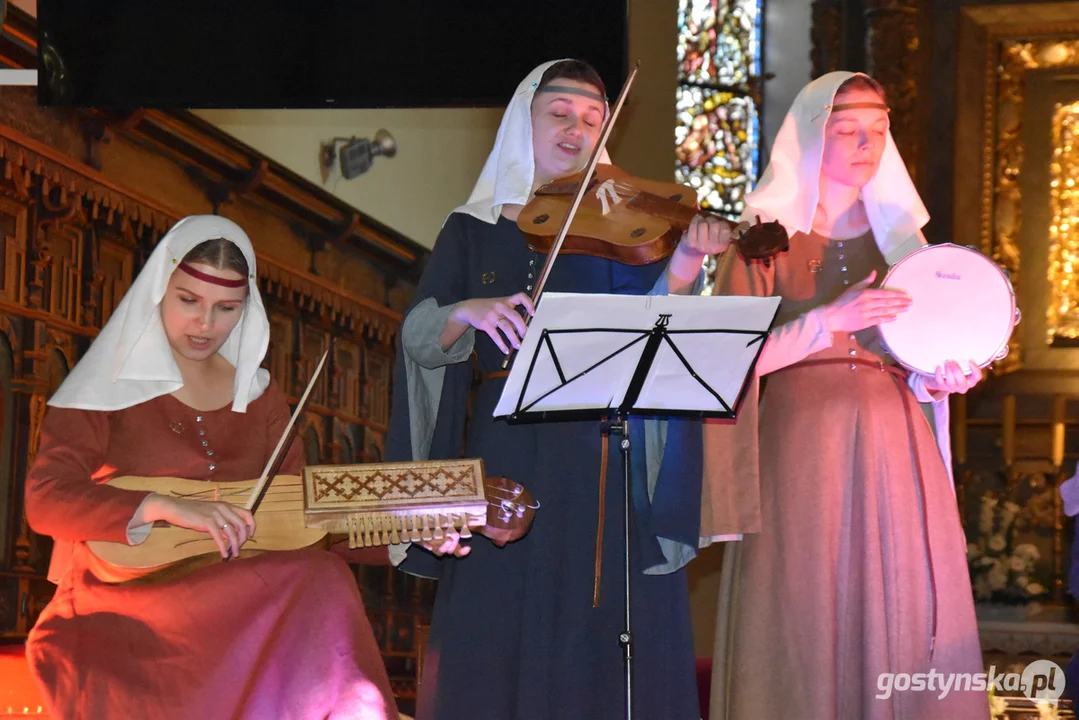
[303,459,488,548]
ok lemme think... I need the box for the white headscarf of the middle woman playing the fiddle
[453,60,611,225]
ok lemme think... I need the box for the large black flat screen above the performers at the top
[38,0,628,108]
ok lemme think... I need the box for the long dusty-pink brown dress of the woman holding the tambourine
[705,233,988,720]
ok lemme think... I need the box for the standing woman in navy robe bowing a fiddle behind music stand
[386,59,730,720]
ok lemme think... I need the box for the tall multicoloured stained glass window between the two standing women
[674,0,763,218]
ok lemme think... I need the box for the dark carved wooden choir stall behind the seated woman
[0,8,433,712]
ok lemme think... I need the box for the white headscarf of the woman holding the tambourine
[742,72,929,264]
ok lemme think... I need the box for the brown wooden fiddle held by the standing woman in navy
[517,164,789,266]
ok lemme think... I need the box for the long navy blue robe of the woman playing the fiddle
[386,214,701,720]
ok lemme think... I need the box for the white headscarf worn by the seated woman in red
[49,215,270,412]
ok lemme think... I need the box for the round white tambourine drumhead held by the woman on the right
[879,245,1017,375]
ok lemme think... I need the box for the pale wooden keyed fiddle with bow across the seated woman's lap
[86,354,538,582]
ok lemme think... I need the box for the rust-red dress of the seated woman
[26,383,398,720]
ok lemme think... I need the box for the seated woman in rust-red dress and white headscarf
[26,216,398,720]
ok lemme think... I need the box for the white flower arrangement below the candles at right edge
[967,493,1047,604]
